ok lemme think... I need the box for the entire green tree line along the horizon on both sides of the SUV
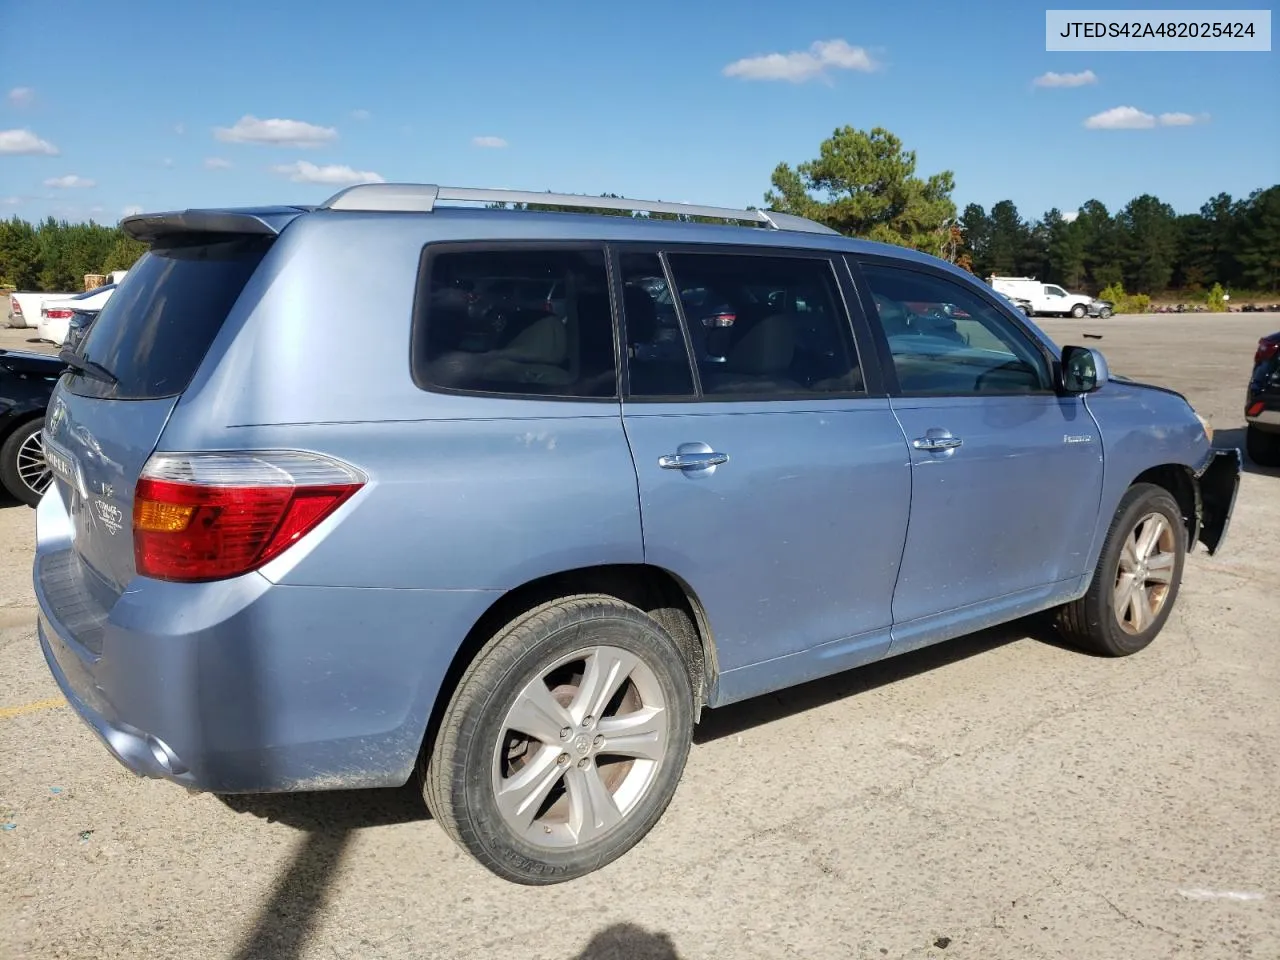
[0,127,1280,296]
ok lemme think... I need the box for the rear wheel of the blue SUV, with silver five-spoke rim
[422,595,694,884]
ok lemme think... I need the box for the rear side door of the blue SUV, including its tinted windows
[614,247,910,699]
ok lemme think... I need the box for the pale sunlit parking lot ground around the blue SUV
[0,311,1280,960]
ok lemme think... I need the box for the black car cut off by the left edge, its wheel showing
[0,349,67,507]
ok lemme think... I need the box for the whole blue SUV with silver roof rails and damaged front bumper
[33,184,1240,883]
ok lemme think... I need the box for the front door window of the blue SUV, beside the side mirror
[863,265,1048,396]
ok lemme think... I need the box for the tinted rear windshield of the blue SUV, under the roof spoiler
[68,237,270,399]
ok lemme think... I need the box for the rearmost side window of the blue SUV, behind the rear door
[413,248,617,397]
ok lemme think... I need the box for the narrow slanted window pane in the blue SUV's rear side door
[621,253,694,397]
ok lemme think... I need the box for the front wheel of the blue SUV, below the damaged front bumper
[1057,484,1187,657]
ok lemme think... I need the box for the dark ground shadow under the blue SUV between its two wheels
[694,614,1064,744]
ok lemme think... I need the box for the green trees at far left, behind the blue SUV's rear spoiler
[0,216,147,292]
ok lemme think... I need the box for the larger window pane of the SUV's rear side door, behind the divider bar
[668,253,863,397]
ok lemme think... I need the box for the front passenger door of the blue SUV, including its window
[860,259,1102,652]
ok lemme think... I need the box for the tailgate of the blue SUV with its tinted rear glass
[45,234,270,595]
